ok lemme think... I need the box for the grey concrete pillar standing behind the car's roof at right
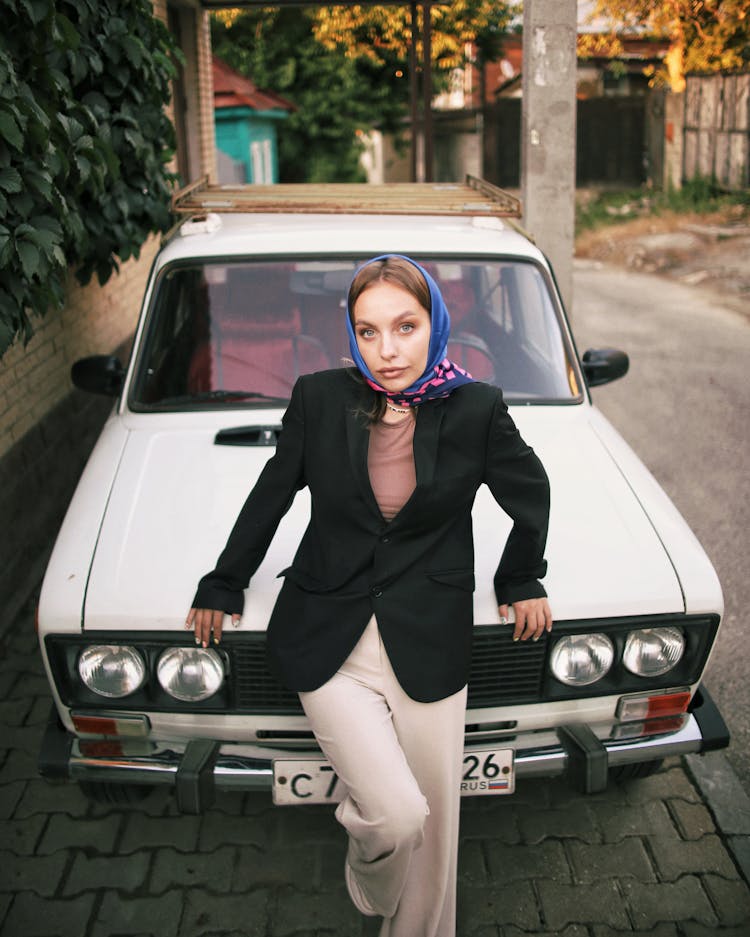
[521,0,577,314]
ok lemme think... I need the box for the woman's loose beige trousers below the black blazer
[300,617,466,937]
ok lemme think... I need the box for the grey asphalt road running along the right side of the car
[573,261,750,792]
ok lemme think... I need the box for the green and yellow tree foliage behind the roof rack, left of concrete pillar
[212,0,510,182]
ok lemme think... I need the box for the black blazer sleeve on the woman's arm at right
[484,392,550,605]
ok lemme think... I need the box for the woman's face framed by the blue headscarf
[354,280,430,393]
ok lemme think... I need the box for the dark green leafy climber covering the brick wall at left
[0,0,175,355]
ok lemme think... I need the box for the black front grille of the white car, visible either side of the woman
[224,626,547,715]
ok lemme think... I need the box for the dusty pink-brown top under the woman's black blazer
[367,416,417,521]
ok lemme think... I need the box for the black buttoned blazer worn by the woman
[193,369,549,702]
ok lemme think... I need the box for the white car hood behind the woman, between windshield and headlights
[84,407,684,630]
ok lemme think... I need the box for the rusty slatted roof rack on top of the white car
[172,175,521,218]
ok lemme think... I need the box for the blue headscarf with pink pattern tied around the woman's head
[346,254,474,407]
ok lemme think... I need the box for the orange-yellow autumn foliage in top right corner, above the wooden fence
[579,0,750,91]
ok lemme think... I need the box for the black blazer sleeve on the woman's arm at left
[193,378,312,614]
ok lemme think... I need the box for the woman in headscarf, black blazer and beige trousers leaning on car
[187,255,552,937]
